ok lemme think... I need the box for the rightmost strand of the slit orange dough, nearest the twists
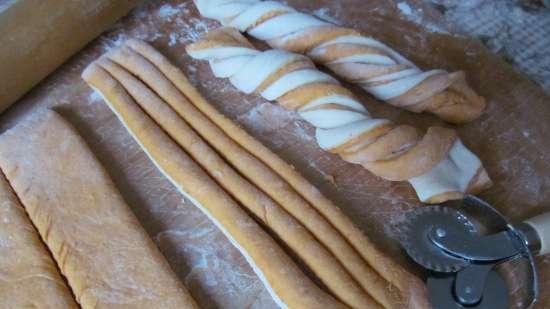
[123,40,429,308]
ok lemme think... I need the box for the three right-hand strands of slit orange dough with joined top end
[84,40,434,308]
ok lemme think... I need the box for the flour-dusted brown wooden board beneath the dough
[0,0,550,309]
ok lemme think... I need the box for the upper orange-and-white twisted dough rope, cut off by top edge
[194,0,486,123]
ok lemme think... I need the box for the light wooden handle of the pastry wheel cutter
[522,212,550,255]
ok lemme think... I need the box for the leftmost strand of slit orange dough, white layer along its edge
[83,63,349,309]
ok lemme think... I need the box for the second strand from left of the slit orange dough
[97,56,384,309]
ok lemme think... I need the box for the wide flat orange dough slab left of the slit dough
[0,111,199,309]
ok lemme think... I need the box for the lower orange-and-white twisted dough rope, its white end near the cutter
[187,28,491,203]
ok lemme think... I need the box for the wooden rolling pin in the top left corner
[0,0,140,112]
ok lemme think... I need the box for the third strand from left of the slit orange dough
[109,40,412,308]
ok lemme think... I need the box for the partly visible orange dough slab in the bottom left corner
[0,174,79,309]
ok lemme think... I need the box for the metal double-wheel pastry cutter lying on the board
[397,196,550,309]
